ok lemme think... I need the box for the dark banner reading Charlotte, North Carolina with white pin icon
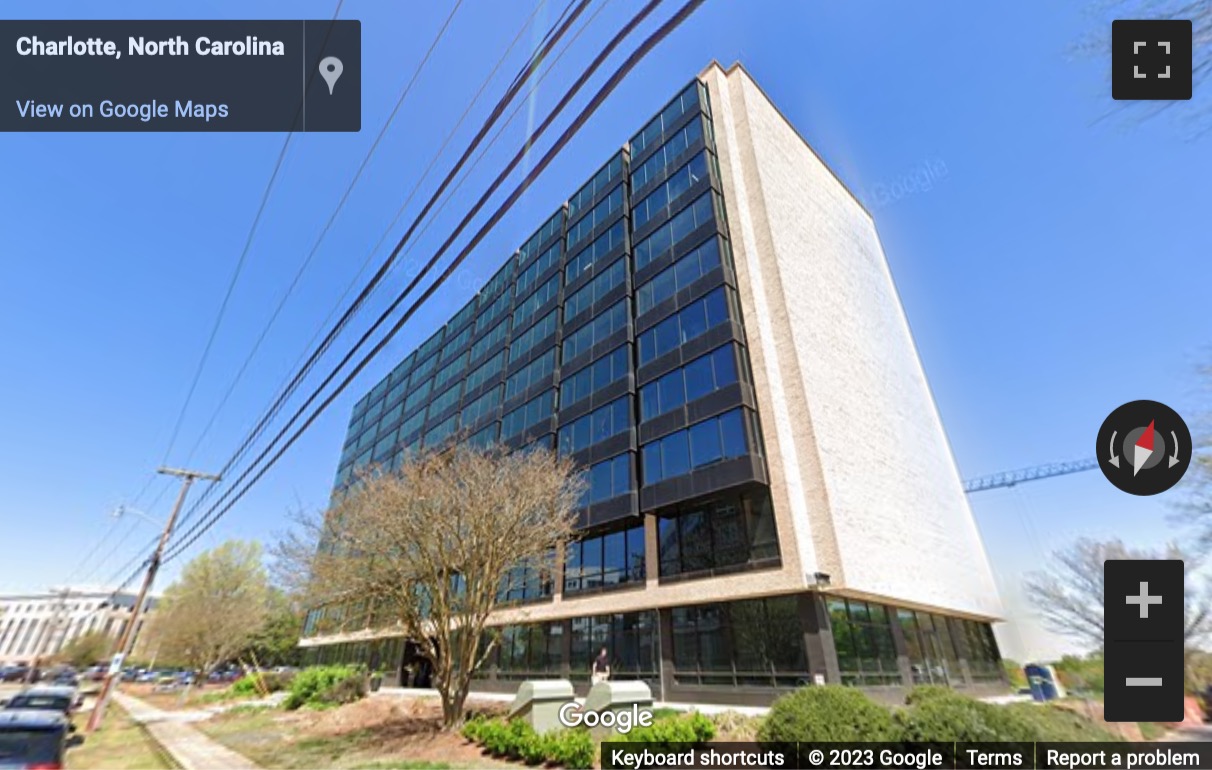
[0,21,362,131]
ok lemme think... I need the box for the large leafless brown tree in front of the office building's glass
[275,444,584,728]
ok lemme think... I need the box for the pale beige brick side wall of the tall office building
[703,64,1002,616]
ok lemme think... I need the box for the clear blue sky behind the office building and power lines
[0,0,1212,654]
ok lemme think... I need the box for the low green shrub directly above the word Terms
[896,690,1036,742]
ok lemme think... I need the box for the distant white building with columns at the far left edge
[0,586,156,663]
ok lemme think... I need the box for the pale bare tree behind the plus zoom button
[1024,538,1212,649]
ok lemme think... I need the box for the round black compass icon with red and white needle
[1097,400,1191,495]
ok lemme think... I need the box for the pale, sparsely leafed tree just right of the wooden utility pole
[145,540,269,675]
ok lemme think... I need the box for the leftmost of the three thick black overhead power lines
[167,0,590,533]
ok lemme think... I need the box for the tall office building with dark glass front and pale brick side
[295,64,1005,703]
